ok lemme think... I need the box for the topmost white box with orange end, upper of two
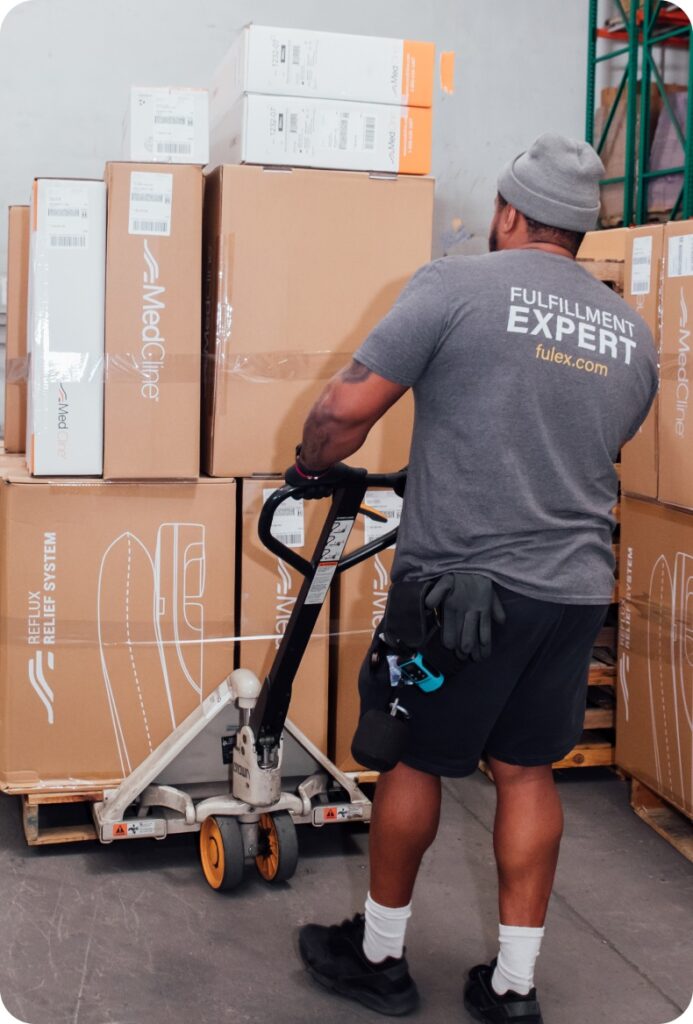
[211,25,435,125]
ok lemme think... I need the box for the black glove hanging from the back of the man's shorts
[426,572,506,662]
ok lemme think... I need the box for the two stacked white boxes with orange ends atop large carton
[212,25,434,174]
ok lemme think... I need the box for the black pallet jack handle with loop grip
[251,470,406,756]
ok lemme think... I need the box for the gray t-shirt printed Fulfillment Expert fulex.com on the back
[355,249,657,604]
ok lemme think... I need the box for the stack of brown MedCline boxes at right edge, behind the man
[616,221,693,816]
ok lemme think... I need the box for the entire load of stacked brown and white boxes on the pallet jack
[0,28,433,792]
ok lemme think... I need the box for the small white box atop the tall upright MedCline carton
[123,85,210,165]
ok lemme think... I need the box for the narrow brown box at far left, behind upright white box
[4,206,30,452]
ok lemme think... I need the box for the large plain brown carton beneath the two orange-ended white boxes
[203,167,433,476]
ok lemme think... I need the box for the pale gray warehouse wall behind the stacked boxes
[0,0,589,273]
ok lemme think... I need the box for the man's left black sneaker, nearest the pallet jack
[299,913,419,1017]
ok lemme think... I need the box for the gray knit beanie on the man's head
[499,132,604,231]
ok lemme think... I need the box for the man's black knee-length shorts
[358,585,608,777]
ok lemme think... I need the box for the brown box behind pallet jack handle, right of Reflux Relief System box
[237,476,330,752]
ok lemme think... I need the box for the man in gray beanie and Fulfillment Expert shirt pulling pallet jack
[287,134,657,1024]
